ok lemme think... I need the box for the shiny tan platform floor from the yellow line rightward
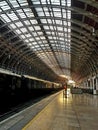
[22,93,98,130]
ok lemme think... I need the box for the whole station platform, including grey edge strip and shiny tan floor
[0,91,98,130]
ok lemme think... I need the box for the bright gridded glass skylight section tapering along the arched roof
[0,0,71,74]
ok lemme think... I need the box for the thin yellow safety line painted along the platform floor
[22,93,57,130]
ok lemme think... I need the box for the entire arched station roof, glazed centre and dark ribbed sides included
[0,0,98,83]
